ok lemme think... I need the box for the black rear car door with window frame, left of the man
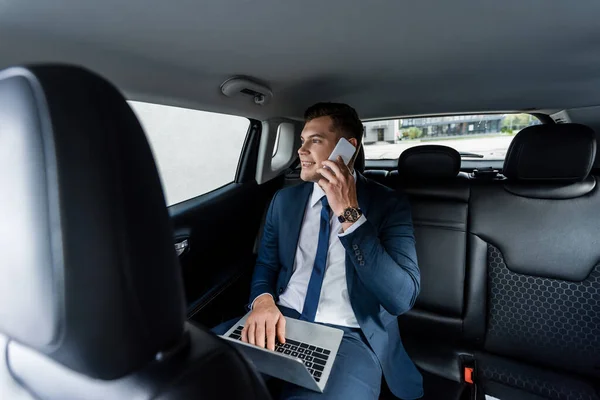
[169,120,283,326]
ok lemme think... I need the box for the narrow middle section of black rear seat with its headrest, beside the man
[386,145,469,399]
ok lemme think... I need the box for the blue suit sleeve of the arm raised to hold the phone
[340,192,420,316]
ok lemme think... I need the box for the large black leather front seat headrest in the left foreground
[0,66,185,379]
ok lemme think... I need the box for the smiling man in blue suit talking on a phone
[216,103,423,400]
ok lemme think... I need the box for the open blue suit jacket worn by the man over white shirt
[250,174,423,399]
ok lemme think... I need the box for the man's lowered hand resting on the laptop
[242,296,285,350]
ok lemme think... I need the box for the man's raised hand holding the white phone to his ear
[317,157,358,225]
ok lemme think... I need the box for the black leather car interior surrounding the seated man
[0,0,600,400]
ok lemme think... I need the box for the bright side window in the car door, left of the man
[129,101,250,206]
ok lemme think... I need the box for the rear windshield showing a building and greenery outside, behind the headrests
[363,114,540,160]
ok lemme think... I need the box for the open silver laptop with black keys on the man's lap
[221,313,344,393]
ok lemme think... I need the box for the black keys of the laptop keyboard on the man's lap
[229,325,331,382]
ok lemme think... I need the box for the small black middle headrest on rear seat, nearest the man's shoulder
[398,144,460,179]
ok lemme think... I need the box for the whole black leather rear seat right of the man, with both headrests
[276,130,600,400]
